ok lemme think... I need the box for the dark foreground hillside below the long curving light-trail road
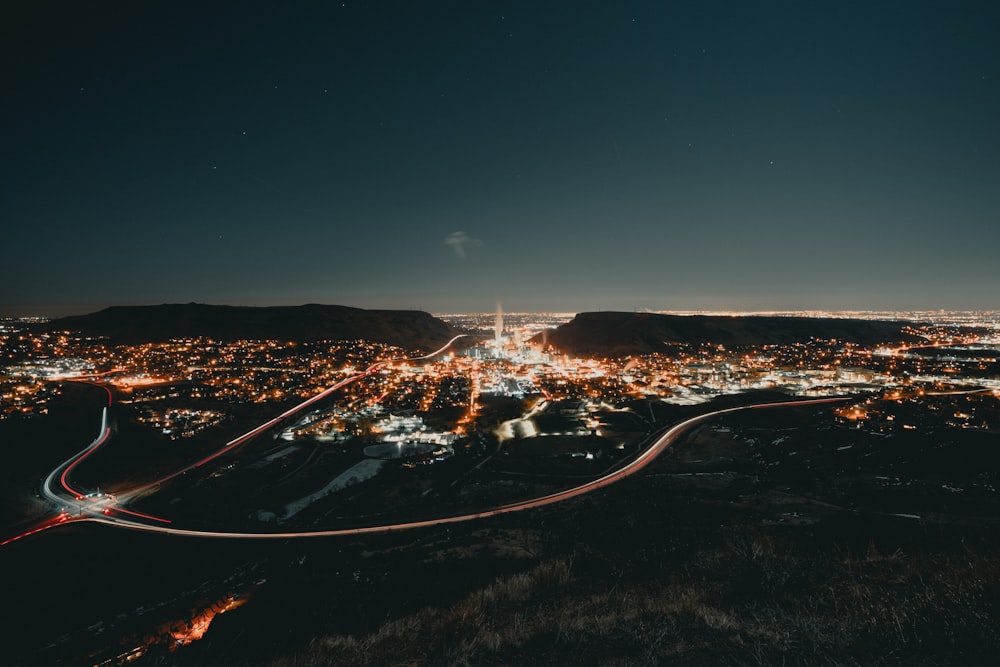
[0,393,1000,666]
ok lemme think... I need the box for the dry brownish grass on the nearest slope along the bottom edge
[264,536,1000,667]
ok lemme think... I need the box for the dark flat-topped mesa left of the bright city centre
[46,303,460,350]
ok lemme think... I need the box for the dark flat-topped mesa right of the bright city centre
[532,312,924,357]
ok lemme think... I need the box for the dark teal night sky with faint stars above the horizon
[0,0,1000,315]
